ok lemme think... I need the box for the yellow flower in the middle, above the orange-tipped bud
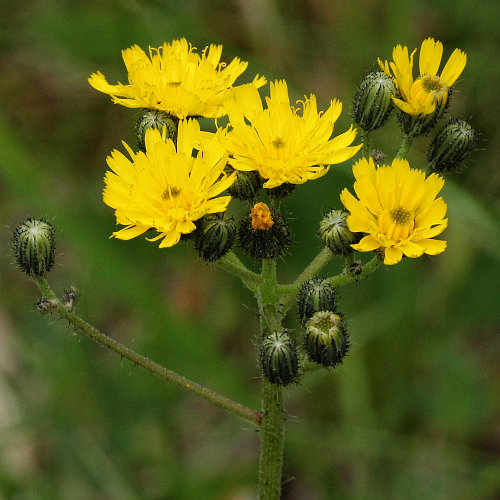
[224,80,361,189]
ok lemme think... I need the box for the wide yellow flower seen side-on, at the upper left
[89,38,266,119]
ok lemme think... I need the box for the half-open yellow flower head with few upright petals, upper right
[378,38,467,116]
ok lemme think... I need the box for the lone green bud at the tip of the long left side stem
[12,218,55,276]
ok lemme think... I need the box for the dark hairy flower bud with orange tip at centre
[238,202,290,260]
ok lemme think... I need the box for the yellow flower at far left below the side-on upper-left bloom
[103,120,235,248]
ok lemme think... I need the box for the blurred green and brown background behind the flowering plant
[0,0,500,500]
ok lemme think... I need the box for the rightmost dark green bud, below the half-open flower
[427,119,477,172]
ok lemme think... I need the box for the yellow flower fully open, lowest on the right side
[340,158,448,265]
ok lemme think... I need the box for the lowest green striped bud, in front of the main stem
[260,331,299,385]
